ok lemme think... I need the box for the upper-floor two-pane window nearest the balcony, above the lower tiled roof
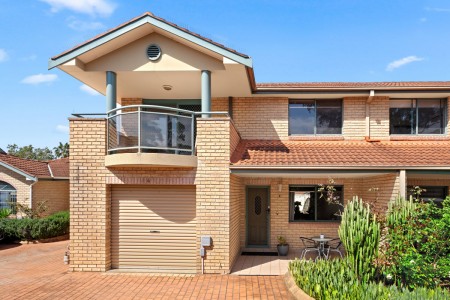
[289,99,342,135]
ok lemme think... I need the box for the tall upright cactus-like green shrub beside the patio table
[338,197,381,283]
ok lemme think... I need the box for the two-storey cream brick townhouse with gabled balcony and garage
[49,13,450,273]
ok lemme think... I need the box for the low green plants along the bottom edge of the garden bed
[289,259,450,300]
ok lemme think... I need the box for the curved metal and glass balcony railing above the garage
[107,105,199,155]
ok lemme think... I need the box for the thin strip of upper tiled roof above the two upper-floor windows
[256,81,450,89]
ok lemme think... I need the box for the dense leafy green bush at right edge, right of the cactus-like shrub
[379,198,450,289]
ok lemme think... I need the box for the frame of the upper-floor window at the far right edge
[389,98,448,136]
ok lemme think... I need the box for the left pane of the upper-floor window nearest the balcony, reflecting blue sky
[289,100,316,134]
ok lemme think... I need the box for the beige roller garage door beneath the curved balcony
[111,185,196,273]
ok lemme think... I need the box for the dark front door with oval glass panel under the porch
[247,187,270,246]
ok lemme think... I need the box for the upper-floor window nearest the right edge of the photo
[389,99,446,134]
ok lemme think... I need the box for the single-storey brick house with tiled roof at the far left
[0,151,69,215]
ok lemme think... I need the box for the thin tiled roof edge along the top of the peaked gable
[51,12,250,59]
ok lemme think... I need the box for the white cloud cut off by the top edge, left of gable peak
[40,0,117,17]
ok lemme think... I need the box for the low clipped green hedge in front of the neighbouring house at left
[0,211,69,240]
